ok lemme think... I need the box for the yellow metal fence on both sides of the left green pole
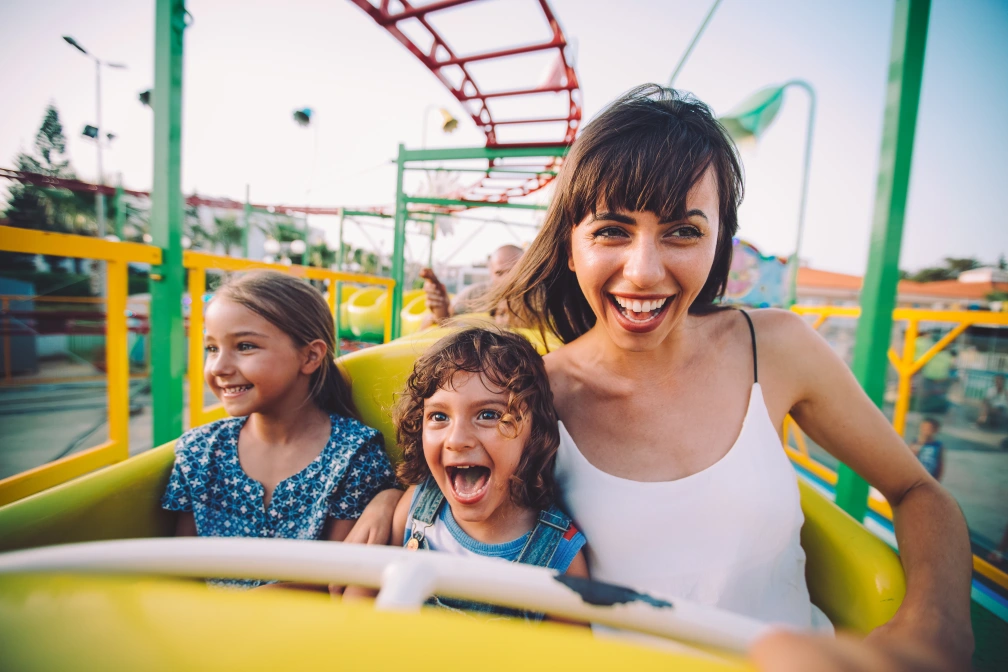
[0,227,395,506]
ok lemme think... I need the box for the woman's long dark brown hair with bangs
[487,84,743,343]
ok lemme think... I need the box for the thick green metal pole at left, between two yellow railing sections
[150,0,188,445]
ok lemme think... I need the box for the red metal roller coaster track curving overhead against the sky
[351,0,582,201]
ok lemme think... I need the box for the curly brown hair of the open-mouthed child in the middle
[392,326,559,510]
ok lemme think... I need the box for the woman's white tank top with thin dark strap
[556,315,831,629]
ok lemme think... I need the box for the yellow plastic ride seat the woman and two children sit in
[0,328,906,633]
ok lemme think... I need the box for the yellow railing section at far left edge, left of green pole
[0,227,161,506]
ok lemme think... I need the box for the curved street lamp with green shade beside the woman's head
[721,80,815,307]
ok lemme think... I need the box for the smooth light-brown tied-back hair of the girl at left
[215,271,357,419]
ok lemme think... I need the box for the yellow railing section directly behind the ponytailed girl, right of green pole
[182,252,395,427]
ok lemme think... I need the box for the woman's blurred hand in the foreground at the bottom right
[750,627,972,672]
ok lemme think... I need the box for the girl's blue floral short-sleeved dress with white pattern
[161,414,395,587]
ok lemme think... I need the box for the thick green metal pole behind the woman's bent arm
[837,0,930,520]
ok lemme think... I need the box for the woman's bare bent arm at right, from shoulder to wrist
[756,310,973,668]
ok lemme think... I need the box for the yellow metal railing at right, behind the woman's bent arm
[782,305,1008,588]
